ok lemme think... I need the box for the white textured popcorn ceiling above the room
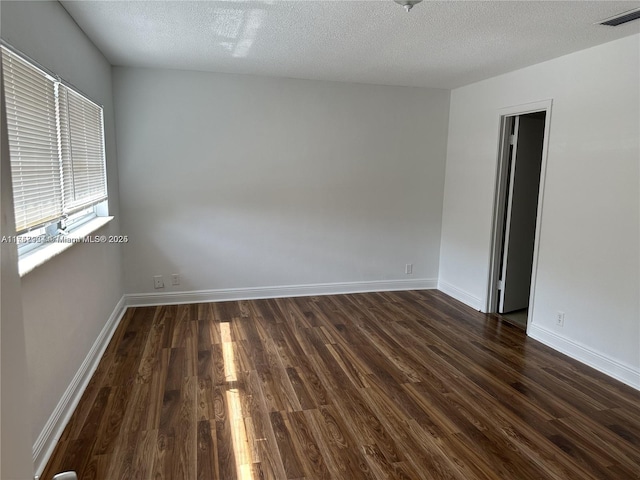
[61,0,640,88]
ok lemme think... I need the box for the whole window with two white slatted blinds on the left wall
[2,45,107,256]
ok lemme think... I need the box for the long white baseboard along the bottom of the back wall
[125,278,437,307]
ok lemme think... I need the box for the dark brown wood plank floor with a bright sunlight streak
[41,290,640,480]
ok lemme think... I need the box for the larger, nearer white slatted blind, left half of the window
[2,49,62,233]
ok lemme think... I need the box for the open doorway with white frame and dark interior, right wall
[487,102,551,328]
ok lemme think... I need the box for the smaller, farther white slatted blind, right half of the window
[58,85,107,214]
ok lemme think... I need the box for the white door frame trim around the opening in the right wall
[485,99,553,328]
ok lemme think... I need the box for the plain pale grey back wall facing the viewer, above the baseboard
[114,68,449,293]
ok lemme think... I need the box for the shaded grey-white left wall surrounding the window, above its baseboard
[2,1,123,458]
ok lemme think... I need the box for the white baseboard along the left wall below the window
[33,296,126,475]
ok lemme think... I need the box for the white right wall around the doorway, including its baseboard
[440,35,640,388]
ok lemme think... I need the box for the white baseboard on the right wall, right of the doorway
[527,323,640,390]
